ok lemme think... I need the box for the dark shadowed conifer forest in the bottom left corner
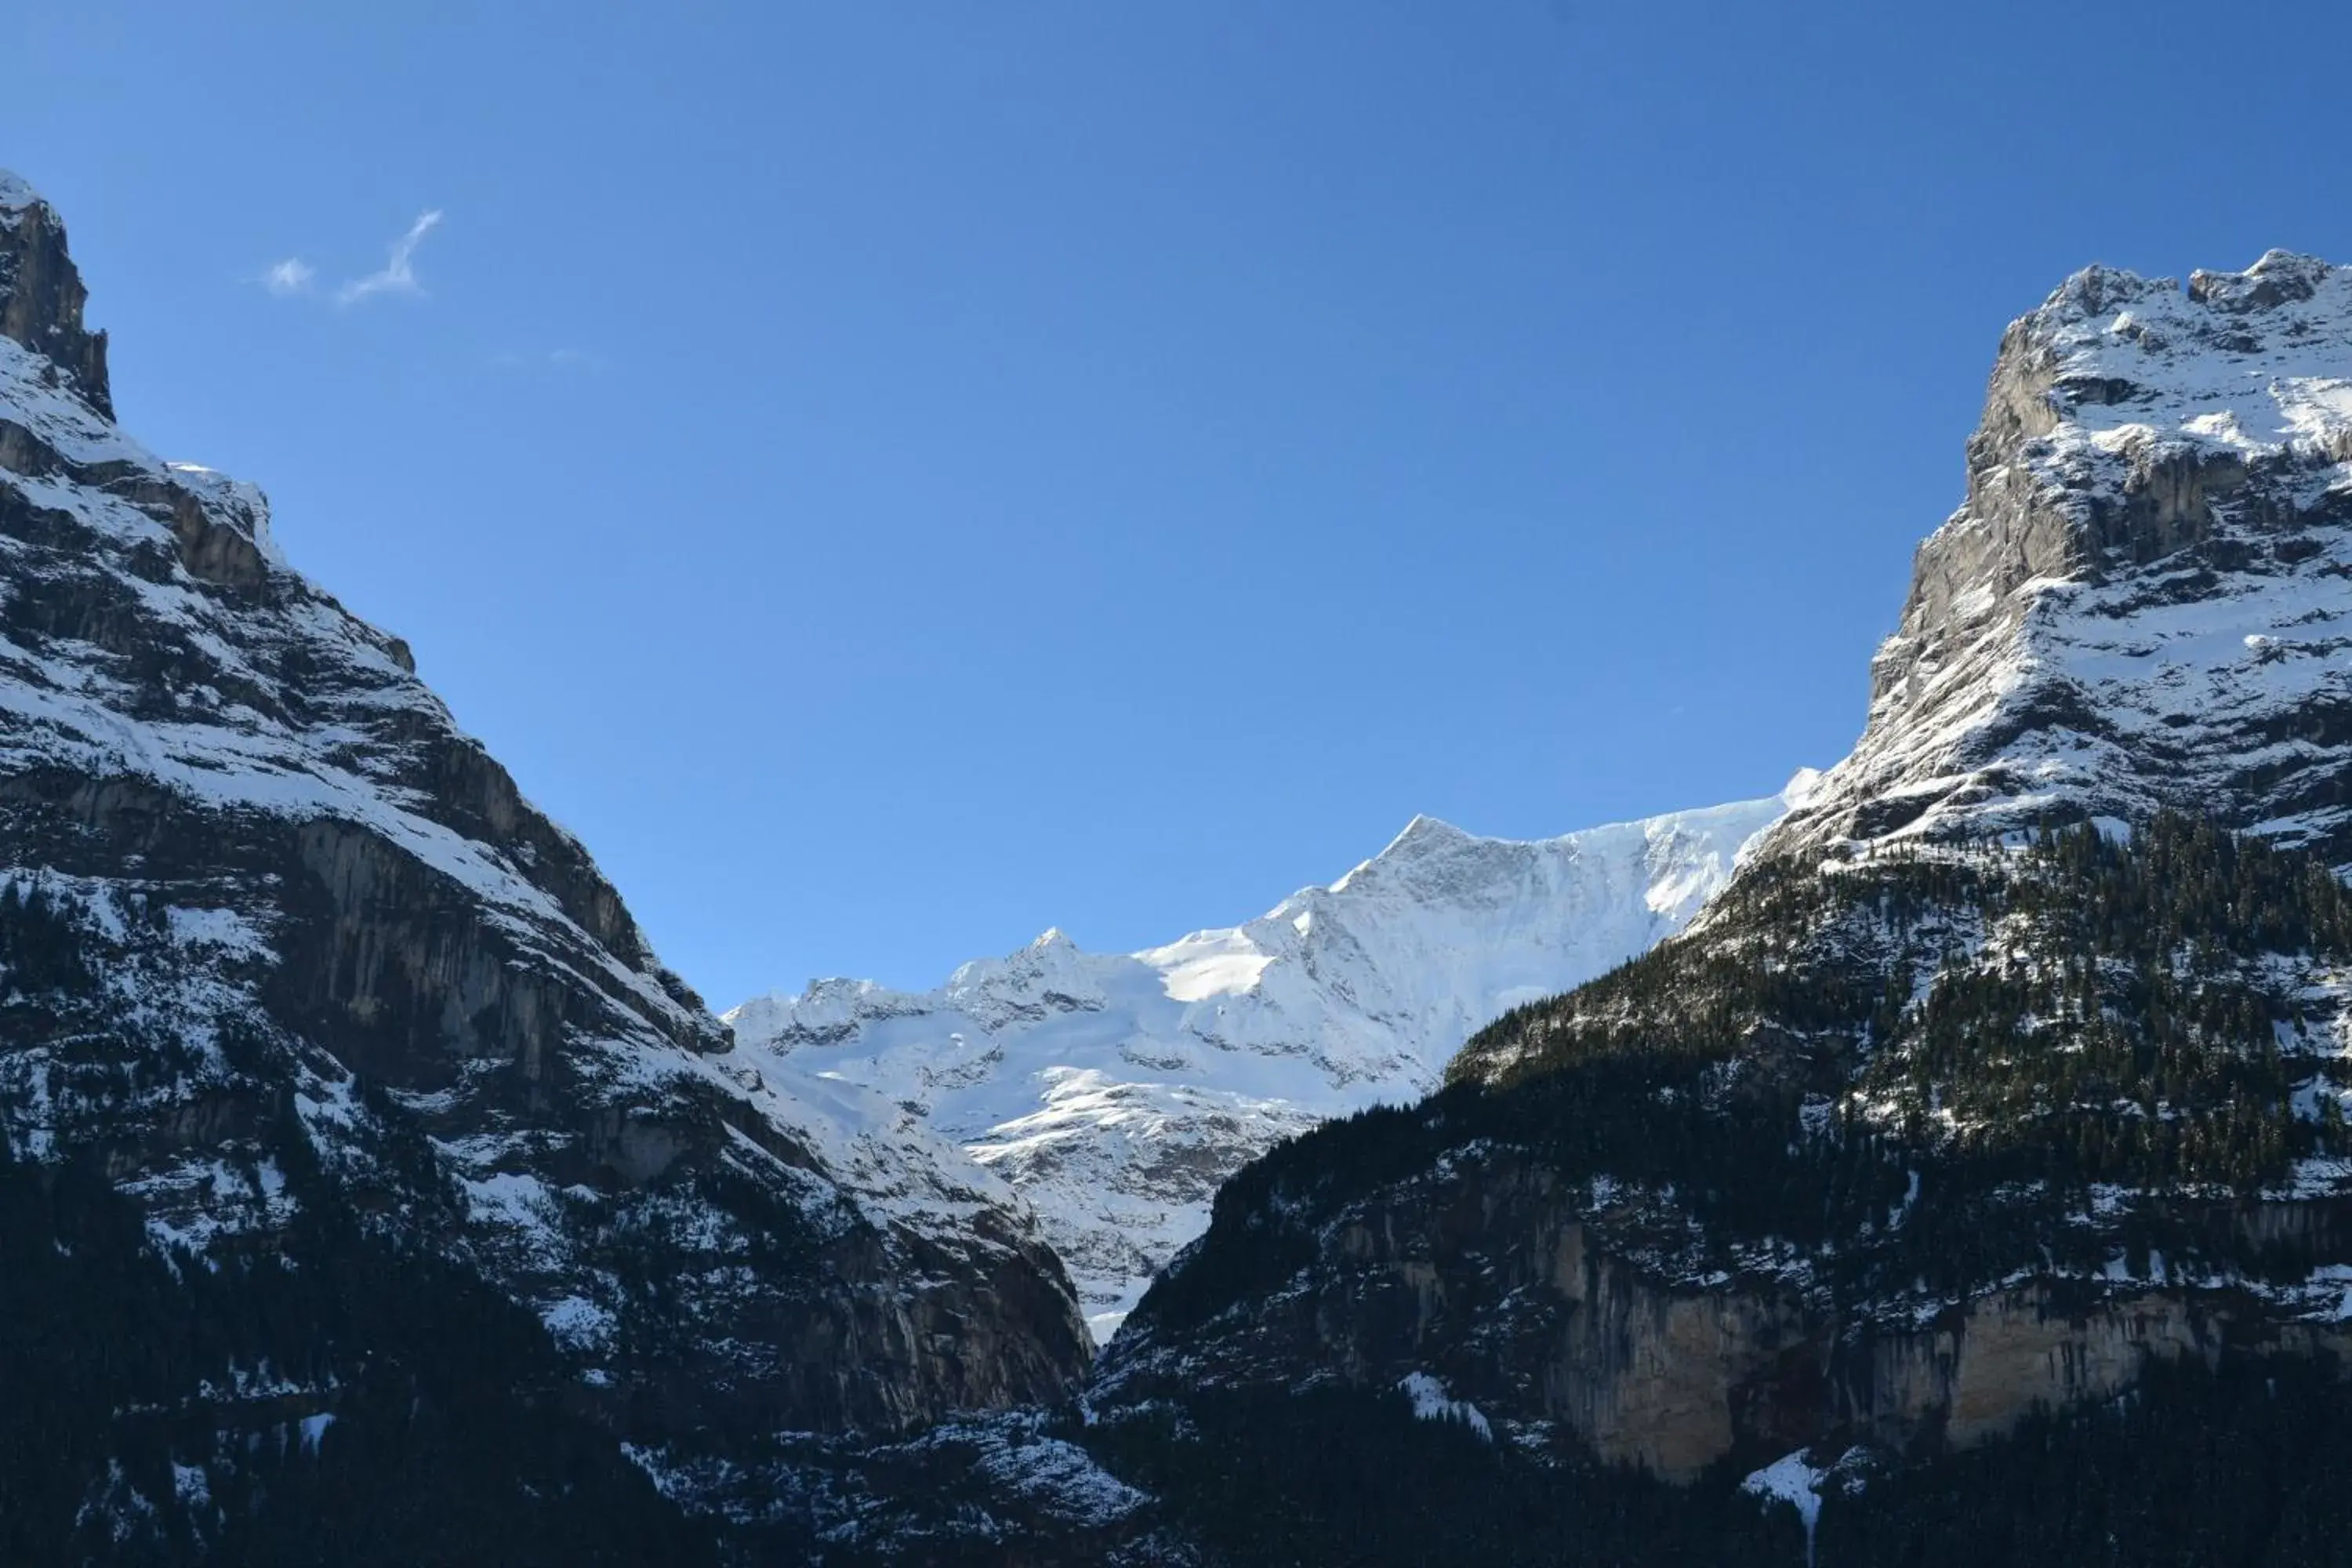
[0,1109,715,1568]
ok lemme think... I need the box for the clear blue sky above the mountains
[0,0,2352,1006]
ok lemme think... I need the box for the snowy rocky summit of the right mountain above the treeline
[1776,252,2352,865]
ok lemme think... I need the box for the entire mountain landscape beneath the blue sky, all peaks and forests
[0,162,2352,1568]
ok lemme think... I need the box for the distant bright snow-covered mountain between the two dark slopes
[727,774,1816,1338]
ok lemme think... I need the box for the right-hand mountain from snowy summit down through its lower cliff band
[1098,254,2352,1519]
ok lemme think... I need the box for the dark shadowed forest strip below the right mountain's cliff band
[1073,1359,2352,1568]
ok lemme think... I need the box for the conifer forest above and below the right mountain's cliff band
[1096,813,2352,1568]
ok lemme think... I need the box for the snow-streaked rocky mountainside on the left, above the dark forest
[0,179,1087,1561]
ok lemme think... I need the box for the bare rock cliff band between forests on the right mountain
[1105,1128,2352,1483]
